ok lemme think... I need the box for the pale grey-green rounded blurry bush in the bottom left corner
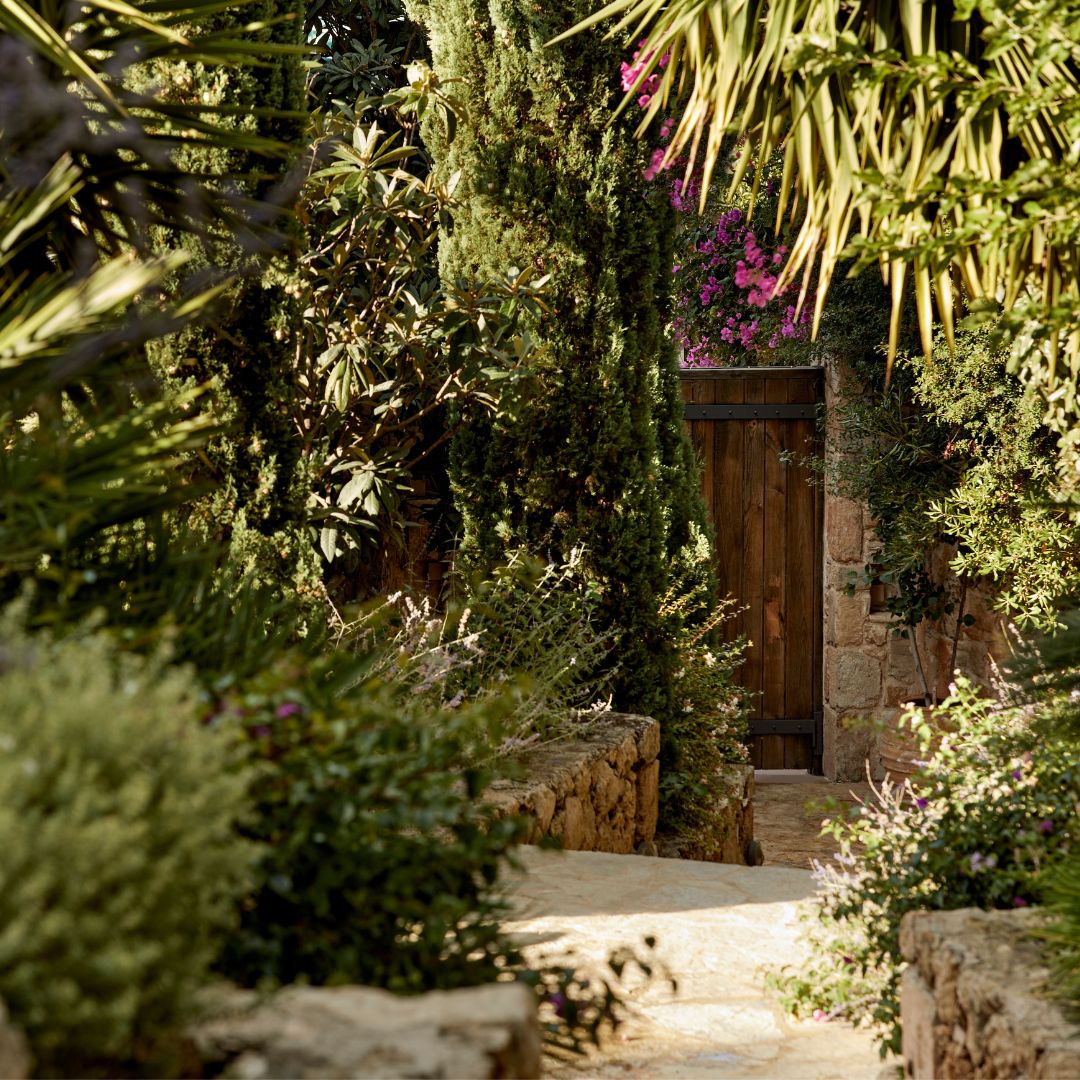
[0,616,253,1076]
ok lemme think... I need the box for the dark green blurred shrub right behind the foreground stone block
[216,654,518,993]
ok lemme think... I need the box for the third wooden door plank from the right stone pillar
[740,373,772,743]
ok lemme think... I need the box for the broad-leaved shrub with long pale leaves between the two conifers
[294,82,540,599]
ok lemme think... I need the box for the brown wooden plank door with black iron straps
[683,367,823,772]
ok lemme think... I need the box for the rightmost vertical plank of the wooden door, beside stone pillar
[784,371,821,769]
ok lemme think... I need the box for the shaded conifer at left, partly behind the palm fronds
[151,0,318,591]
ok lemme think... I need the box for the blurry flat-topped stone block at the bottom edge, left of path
[191,983,541,1080]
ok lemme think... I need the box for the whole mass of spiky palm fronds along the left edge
[0,0,300,623]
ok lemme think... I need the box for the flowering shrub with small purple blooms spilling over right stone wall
[778,680,1080,1054]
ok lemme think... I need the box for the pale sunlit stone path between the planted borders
[511,848,895,1080]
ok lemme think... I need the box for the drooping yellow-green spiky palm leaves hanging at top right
[556,0,1080,397]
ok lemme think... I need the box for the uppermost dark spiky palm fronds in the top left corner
[0,0,302,264]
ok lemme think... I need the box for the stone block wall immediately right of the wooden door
[822,361,1004,780]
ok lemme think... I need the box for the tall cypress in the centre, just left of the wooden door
[409,0,704,715]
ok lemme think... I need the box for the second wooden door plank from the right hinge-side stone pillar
[761,370,791,769]
